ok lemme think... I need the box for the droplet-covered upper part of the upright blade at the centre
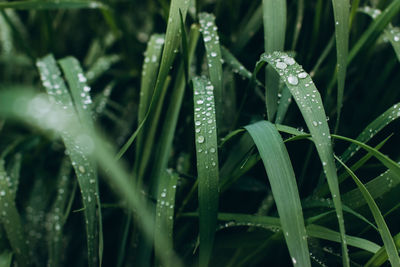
[194,78,217,169]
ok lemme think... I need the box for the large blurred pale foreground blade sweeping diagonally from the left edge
[0,89,182,267]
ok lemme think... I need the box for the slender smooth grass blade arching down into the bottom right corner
[336,157,400,267]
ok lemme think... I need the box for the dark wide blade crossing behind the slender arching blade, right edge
[343,170,400,209]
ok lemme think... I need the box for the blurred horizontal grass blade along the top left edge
[0,0,106,10]
